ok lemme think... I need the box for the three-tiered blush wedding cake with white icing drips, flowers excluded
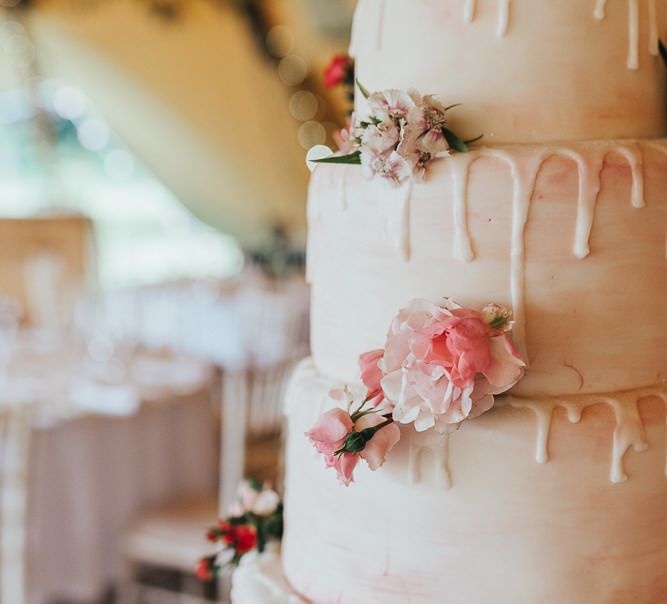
[282,0,667,604]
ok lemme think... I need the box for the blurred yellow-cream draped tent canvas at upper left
[17,0,350,245]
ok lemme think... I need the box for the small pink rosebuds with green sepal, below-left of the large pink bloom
[306,391,400,486]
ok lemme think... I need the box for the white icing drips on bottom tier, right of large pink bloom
[507,386,667,483]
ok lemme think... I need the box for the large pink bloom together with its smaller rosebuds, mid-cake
[306,299,526,486]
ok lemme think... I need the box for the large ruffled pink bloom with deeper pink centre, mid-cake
[379,300,525,432]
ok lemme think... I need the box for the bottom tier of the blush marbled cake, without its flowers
[282,361,667,604]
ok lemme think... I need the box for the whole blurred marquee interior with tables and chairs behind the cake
[0,0,354,604]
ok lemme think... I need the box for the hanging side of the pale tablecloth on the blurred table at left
[27,389,218,604]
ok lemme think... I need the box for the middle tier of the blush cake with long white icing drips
[308,141,667,395]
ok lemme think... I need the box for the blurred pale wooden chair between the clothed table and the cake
[119,359,296,604]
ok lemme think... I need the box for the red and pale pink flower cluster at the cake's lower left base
[196,479,283,581]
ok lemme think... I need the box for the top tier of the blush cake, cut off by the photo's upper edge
[350,0,667,143]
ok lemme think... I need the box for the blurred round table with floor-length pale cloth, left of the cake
[0,336,218,604]
